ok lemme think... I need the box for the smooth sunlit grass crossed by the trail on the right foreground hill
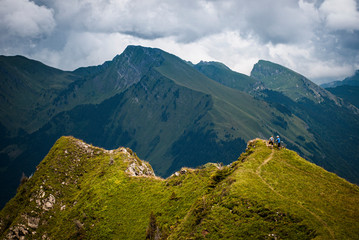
[229,142,359,239]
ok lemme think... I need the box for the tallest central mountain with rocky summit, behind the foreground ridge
[1,46,318,180]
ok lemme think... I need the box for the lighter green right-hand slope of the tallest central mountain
[157,50,316,146]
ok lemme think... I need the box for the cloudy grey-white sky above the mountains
[0,0,359,83]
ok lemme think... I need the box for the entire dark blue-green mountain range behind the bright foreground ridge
[0,46,359,208]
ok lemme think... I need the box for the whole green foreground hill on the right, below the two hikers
[171,140,359,239]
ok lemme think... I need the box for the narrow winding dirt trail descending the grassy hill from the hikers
[256,149,335,239]
